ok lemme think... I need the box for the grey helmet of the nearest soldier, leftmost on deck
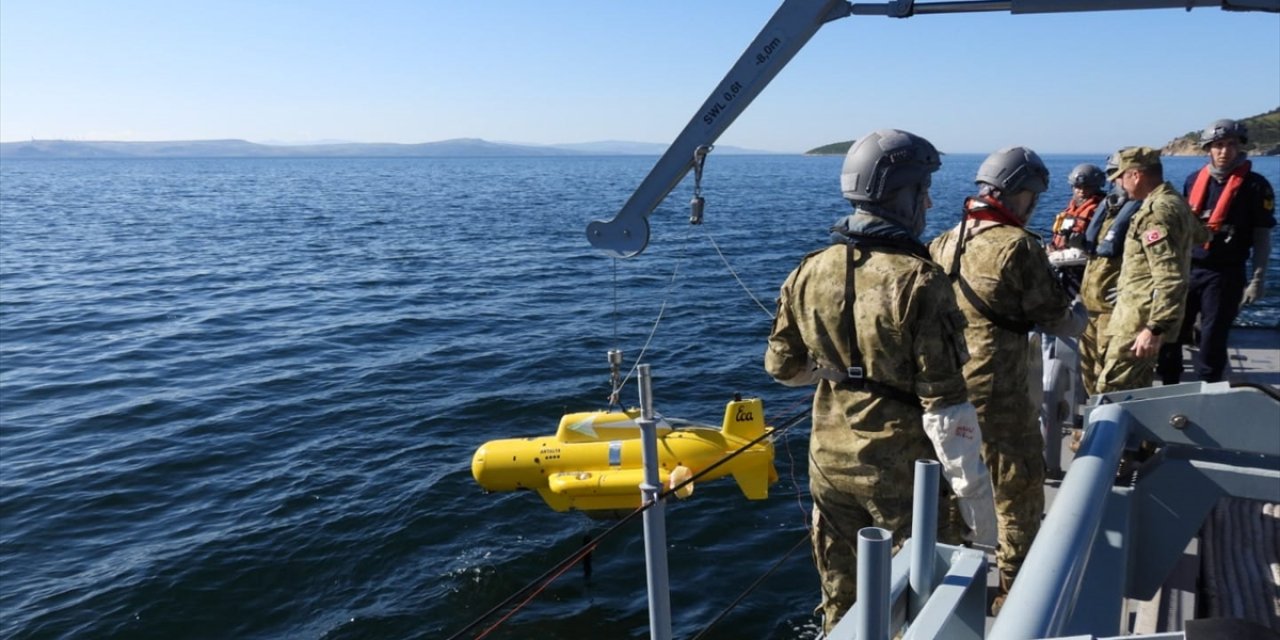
[840,129,942,204]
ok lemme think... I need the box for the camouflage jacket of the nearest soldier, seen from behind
[764,235,968,494]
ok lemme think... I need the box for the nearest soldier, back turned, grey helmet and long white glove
[764,129,996,631]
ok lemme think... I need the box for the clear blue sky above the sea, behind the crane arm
[0,0,1280,152]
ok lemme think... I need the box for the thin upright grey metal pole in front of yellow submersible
[636,365,671,640]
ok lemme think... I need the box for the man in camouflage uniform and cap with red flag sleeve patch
[1098,147,1198,393]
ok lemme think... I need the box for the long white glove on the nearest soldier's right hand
[922,402,998,547]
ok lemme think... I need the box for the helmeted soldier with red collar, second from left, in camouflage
[929,147,1084,611]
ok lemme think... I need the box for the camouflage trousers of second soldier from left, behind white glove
[982,425,1044,585]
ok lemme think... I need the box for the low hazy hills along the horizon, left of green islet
[0,138,771,159]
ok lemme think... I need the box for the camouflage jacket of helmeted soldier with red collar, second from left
[929,221,1071,440]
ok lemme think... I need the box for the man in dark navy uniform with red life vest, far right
[1158,120,1276,384]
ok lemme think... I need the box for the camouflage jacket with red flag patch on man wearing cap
[1106,182,1204,342]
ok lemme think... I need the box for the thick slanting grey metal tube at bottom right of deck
[987,404,1133,640]
